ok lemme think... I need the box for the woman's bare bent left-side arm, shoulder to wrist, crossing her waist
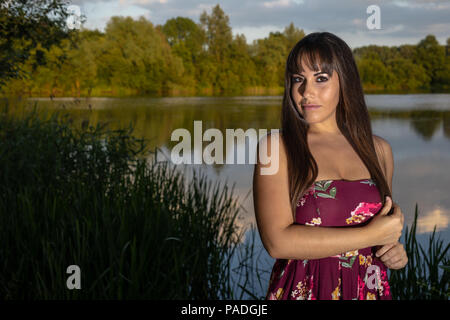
[253,133,390,259]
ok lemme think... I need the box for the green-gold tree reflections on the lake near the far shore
[14,96,450,166]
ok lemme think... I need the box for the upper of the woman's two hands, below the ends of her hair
[366,197,404,246]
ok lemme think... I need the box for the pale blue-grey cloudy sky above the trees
[71,0,450,48]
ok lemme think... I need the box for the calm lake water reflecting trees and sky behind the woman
[26,94,450,294]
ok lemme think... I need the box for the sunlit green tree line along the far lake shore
[0,5,450,96]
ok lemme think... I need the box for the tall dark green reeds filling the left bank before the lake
[0,102,253,300]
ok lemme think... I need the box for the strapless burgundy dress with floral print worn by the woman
[266,179,392,300]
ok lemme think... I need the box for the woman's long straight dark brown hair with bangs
[281,32,391,219]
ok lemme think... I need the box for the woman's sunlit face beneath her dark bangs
[291,60,339,128]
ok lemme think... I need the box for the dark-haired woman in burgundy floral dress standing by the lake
[253,32,408,299]
